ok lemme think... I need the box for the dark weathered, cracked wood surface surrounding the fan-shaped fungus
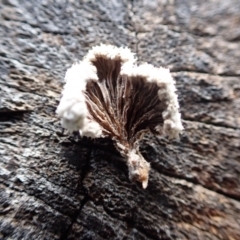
[0,0,240,239]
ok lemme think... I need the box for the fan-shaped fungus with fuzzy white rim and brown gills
[56,44,183,188]
